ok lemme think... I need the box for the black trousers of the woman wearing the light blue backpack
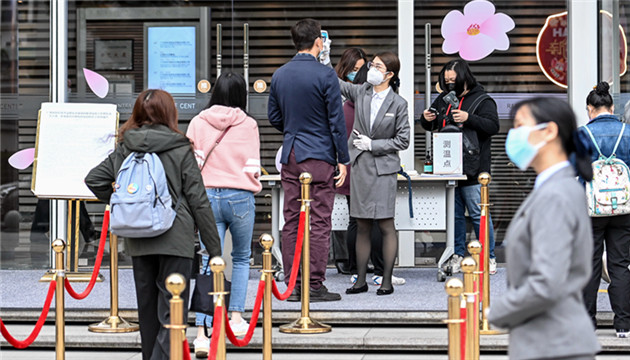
[132,255,193,360]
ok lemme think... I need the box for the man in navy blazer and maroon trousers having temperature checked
[267,19,350,302]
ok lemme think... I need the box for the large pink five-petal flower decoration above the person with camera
[441,0,514,61]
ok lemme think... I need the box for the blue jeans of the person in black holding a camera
[455,185,496,259]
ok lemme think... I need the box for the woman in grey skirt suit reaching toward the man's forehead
[339,52,410,295]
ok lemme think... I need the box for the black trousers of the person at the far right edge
[584,215,630,329]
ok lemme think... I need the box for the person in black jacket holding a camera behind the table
[420,59,499,274]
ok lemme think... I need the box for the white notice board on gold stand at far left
[31,103,118,199]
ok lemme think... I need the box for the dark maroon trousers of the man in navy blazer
[281,150,335,289]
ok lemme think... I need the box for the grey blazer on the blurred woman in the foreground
[488,166,600,359]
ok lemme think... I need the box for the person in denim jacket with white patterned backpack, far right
[580,82,630,338]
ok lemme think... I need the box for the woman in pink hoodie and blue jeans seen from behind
[186,72,262,358]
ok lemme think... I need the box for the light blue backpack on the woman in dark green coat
[109,152,181,238]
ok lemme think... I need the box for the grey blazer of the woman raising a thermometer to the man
[339,79,410,176]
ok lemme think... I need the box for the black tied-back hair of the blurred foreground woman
[511,97,593,181]
